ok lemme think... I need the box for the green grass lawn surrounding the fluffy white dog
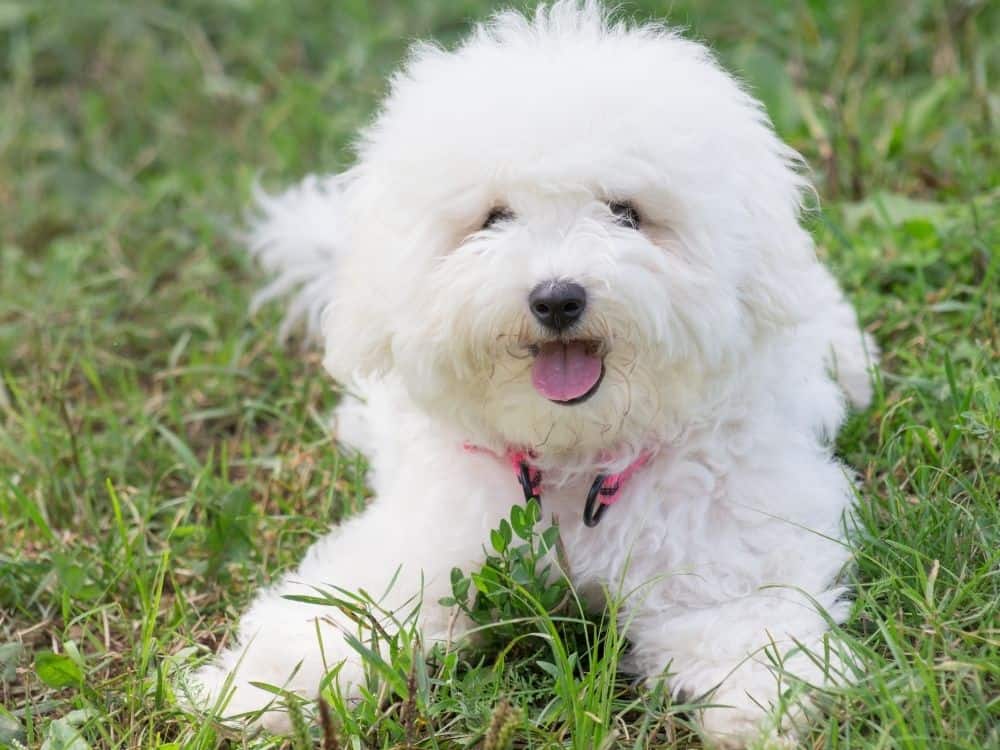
[0,0,1000,750]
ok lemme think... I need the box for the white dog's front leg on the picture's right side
[623,452,852,747]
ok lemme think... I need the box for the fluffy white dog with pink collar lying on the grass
[188,0,870,746]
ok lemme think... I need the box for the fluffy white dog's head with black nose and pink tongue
[325,3,812,453]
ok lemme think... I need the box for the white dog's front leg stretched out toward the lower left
[180,438,517,731]
